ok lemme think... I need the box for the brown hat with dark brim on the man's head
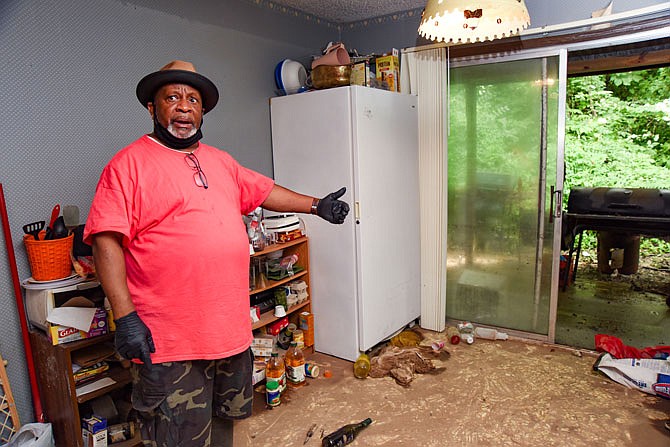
[135,61,219,113]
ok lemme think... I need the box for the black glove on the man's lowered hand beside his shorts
[114,311,156,368]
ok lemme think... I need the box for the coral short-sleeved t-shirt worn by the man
[84,135,274,363]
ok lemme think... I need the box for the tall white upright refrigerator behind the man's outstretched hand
[270,86,421,361]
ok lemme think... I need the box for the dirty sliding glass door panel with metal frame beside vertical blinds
[446,50,566,341]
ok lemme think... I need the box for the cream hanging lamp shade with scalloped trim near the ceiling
[419,0,530,44]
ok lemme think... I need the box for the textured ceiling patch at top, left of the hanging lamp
[272,0,427,24]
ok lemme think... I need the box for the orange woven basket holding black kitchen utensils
[23,234,74,281]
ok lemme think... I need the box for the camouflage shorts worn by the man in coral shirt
[132,349,253,447]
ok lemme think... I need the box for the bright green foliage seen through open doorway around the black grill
[564,67,670,255]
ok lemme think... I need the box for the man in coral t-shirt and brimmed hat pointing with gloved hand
[84,61,349,447]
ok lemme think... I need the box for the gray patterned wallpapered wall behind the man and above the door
[0,0,660,423]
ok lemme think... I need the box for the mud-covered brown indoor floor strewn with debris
[227,331,670,447]
